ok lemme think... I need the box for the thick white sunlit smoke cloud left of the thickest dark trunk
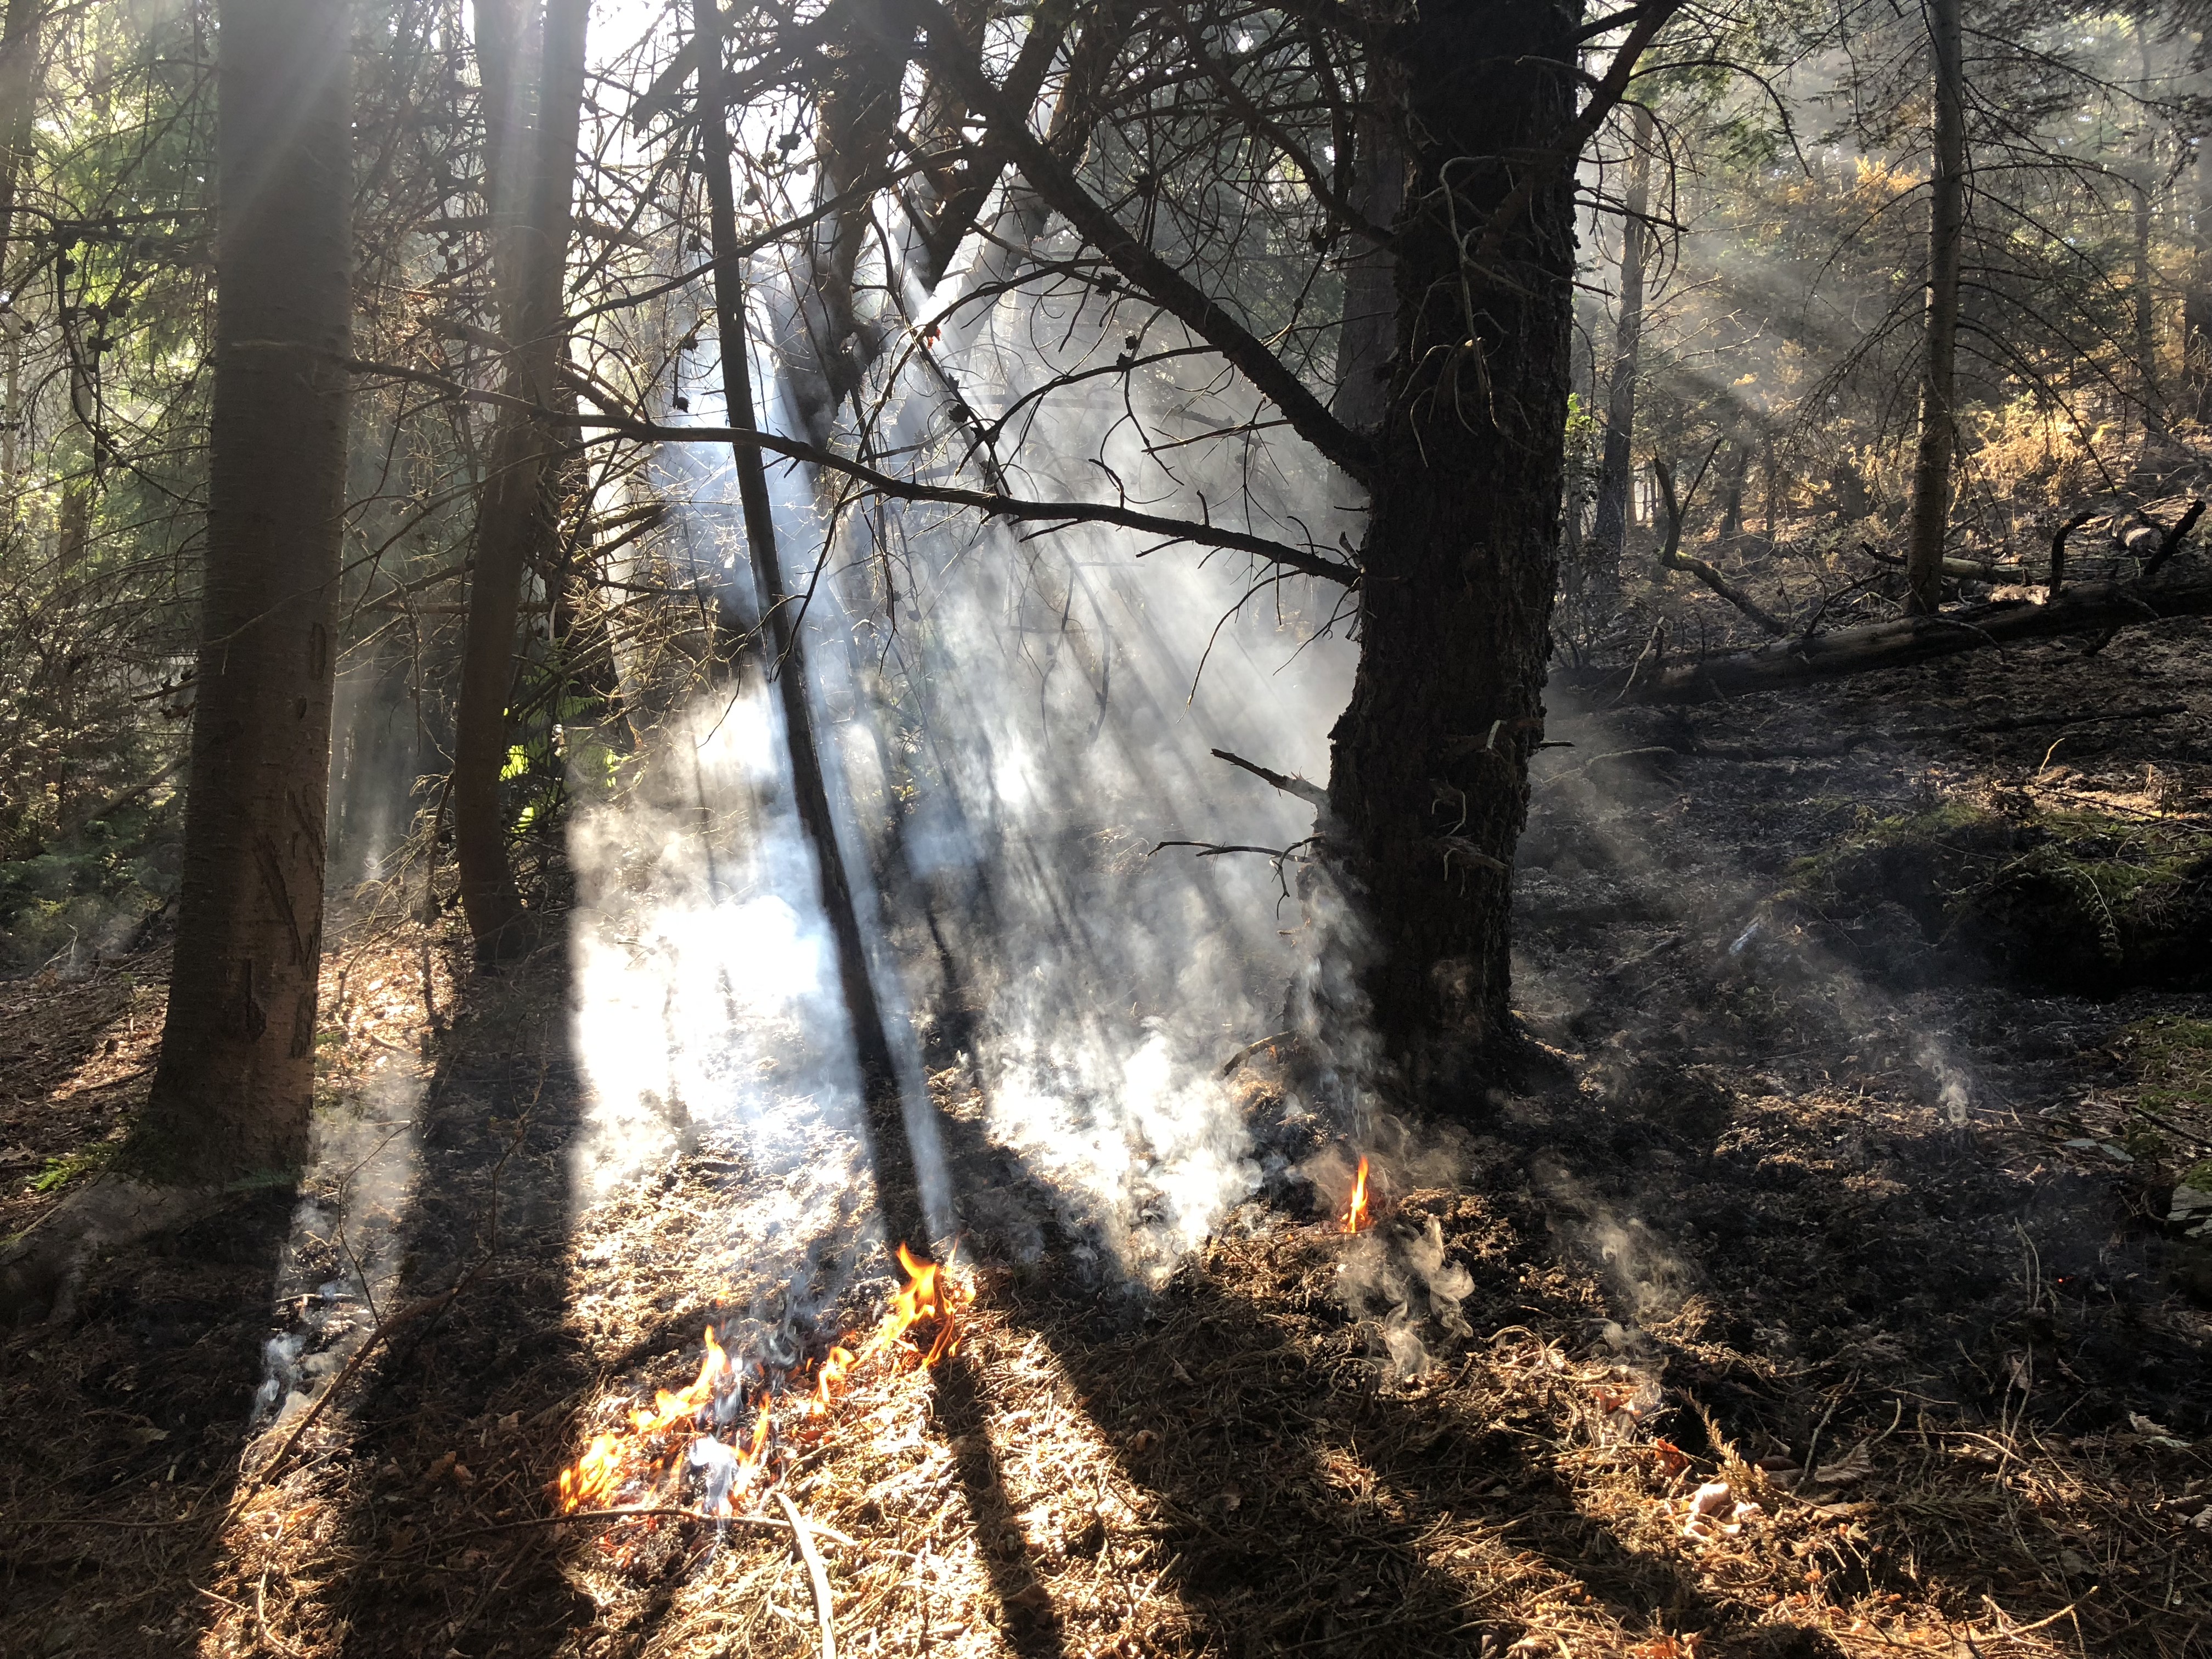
[571,159,1358,1281]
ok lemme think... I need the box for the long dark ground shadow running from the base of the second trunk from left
[325,953,595,1659]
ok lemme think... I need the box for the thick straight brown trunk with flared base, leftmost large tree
[124,0,354,1181]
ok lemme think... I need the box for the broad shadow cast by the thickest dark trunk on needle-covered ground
[940,1092,1836,1659]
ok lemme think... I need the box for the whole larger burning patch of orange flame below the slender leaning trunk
[560,1245,964,1524]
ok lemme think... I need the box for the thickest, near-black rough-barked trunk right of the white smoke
[1323,2,1577,1092]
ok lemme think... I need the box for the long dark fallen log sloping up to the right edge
[1553,579,2212,703]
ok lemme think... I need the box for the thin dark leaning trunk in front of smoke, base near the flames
[692,0,927,1245]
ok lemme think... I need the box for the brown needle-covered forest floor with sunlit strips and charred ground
[0,624,2212,1659]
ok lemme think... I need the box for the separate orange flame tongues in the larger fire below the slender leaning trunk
[560,1245,962,1515]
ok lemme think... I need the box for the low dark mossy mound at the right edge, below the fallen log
[1783,803,2212,995]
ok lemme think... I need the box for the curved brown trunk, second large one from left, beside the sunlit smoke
[454,0,591,967]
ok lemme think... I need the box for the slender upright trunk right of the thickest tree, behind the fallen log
[1905,0,1966,615]
